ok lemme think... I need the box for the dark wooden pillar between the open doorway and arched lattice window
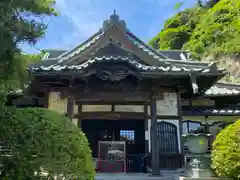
[150,94,160,175]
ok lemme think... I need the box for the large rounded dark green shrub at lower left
[0,108,95,180]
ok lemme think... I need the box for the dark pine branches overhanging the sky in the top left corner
[0,0,55,53]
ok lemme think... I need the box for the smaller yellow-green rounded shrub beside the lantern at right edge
[211,120,240,179]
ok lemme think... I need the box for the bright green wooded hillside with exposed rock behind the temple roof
[150,0,240,83]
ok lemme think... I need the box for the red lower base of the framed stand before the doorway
[98,160,125,173]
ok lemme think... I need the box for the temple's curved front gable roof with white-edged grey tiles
[29,12,223,77]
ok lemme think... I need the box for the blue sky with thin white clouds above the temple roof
[21,0,196,53]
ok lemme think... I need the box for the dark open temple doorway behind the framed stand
[81,120,145,158]
